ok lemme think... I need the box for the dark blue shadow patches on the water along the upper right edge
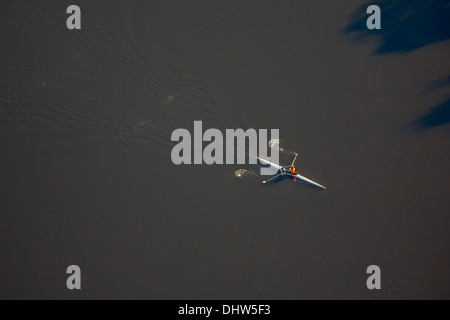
[343,0,450,130]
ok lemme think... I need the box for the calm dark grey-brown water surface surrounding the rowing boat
[0,0,450,299]
